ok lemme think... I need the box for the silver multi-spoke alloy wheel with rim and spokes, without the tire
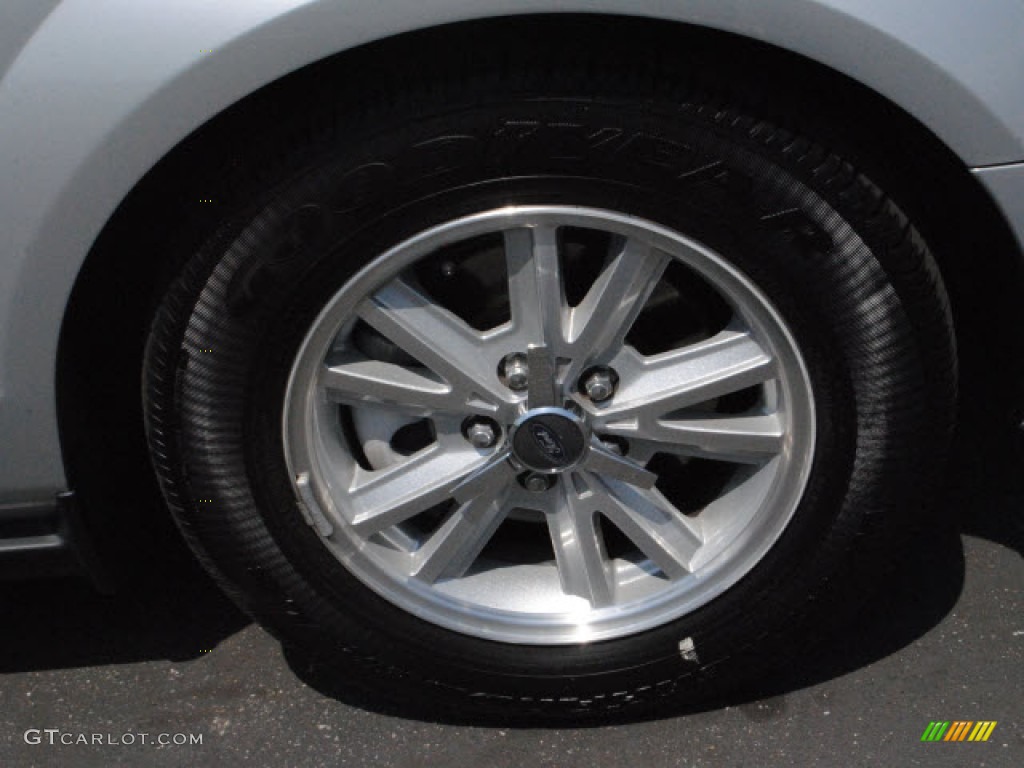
[283,206,815,644]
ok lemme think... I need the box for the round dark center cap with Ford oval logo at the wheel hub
[511,408,590,474]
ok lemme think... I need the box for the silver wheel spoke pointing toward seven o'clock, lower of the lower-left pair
[412,487,508,584]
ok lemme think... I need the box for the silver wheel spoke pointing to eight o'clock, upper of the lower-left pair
[343,437,484,538]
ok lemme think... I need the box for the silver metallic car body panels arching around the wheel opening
[0,0,1024,512]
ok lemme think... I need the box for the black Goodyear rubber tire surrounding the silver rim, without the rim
[144,55,955,713]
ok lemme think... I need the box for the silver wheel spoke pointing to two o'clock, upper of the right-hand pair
[594,331,775,436]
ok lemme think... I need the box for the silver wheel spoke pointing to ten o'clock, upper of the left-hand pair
[358,280,512,417]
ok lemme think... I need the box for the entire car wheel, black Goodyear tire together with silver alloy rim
[144,58,955,713]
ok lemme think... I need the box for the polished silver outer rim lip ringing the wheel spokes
[282,205,816,645]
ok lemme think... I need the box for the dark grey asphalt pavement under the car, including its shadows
[0,450,1024,768]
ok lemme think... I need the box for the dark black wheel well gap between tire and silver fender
[57,15,1024,552]
